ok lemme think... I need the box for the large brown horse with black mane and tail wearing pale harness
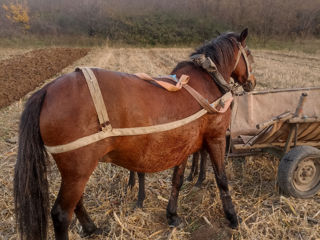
[14,29,255,240]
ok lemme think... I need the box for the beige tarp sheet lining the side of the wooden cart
[231,87,320,143]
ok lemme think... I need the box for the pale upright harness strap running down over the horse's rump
[76,67,112,131]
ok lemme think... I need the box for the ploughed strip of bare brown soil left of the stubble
[0,48,88,108]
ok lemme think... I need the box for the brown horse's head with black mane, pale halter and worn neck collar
[190,28,256,92]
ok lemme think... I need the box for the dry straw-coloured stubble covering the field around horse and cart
[0,44,320,239]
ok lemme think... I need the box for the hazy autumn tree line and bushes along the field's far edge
[0,0,320,45]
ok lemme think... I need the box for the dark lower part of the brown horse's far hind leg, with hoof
[74,196,98,236]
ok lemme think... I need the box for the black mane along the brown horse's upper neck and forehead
[190,32,239,68]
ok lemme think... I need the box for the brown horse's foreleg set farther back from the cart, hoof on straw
[167,159,187,227]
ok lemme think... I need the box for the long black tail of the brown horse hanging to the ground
[14,88,49,240]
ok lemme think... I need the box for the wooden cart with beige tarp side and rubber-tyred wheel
[229,87,320,198]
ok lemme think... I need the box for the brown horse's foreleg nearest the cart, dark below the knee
[207,138,238,228]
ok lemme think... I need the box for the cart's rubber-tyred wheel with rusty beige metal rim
[278,146,320,198]
